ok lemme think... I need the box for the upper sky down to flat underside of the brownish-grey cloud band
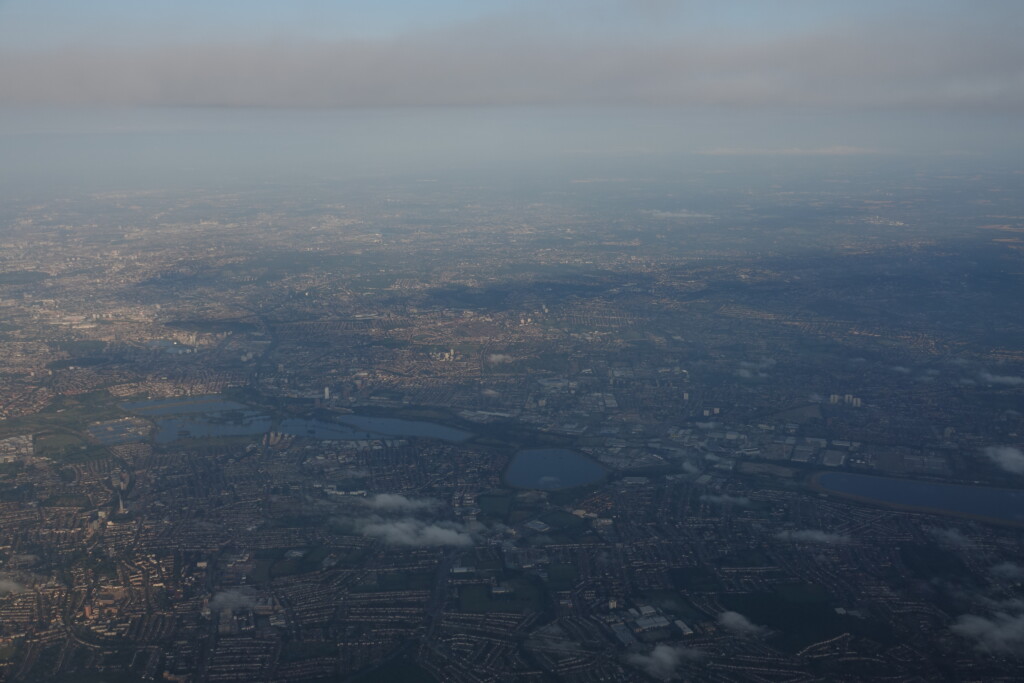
[0,0,1024,111]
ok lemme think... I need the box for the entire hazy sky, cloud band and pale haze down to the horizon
[0,0,1024,194]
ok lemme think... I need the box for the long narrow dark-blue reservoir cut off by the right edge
[817,472,1024,523]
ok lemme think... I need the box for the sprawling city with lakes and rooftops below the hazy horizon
[0,160,1024,681]
